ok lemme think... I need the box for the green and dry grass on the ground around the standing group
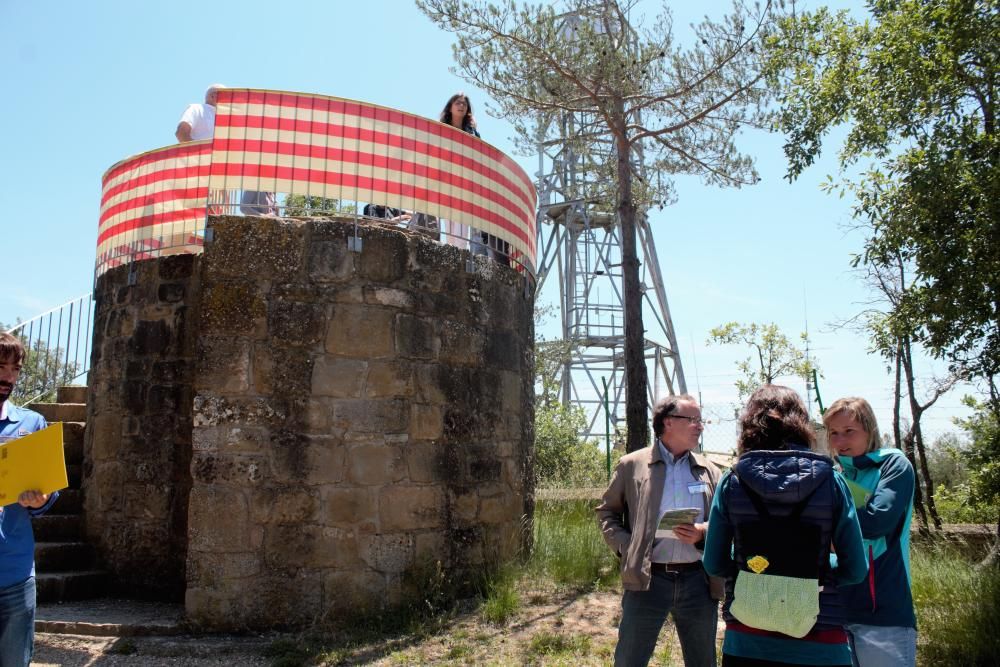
[254,500,1000,667]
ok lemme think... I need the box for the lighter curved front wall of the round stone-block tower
[88,217,534,629]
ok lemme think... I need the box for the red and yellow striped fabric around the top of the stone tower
[98,88,536,273]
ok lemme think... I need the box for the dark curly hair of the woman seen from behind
[736,384,816,454]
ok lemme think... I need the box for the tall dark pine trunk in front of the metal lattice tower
[615,108,650,452]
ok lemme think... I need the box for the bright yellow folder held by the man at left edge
[0,422,69,505]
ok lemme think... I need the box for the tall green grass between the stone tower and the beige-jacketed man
[528,500,618,588]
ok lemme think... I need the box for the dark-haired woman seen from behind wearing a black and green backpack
[704,385,867,667]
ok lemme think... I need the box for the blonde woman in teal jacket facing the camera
[823,397,917,667]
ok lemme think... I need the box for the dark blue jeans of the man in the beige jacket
[615,568,719,667]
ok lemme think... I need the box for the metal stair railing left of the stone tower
[8,294,94,405]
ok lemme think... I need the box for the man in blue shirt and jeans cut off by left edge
[0,333,59,667]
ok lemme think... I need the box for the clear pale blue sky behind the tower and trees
[0,0,964,444]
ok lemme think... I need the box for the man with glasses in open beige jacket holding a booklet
[597,394,723,667]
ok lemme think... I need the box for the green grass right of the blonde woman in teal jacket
[911,545,1000,667]
